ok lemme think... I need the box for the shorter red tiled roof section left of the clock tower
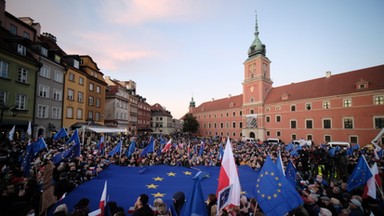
[194,94,243,112]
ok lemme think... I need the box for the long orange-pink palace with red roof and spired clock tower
[189,16,384,146]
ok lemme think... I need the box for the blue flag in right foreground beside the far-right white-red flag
[347,155,372,191]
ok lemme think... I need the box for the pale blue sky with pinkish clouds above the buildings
[6,0,384,118]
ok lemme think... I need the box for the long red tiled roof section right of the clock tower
[265,65,384,104]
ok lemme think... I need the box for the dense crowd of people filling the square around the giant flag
[0,134,384,216]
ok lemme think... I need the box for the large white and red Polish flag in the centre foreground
[216,137,241,206]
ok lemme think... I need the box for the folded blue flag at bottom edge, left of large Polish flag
[180,172,208,216]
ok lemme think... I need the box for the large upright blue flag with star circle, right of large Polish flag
[255,156,303,216]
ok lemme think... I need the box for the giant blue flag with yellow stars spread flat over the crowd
[52,165,258,213]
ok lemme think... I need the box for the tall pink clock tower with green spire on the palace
[242,14,273,140]
